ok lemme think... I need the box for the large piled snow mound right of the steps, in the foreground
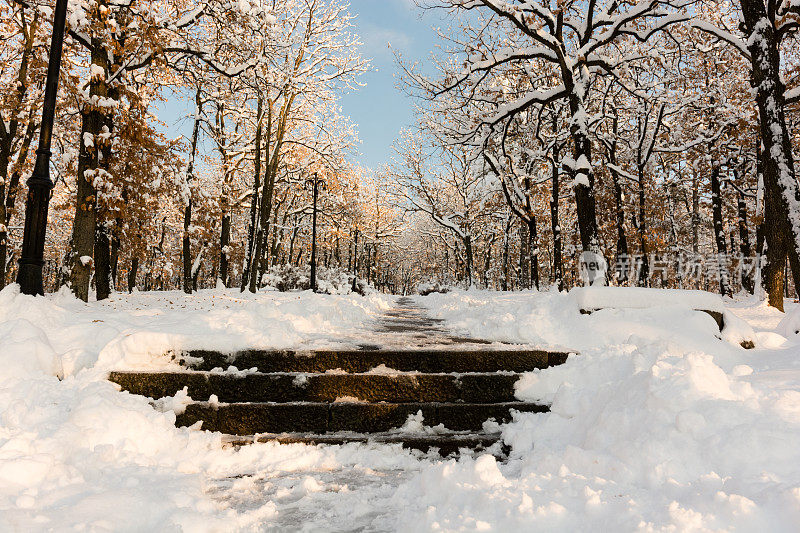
[390,334,800,532]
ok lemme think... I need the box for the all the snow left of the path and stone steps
[0,286,418,531]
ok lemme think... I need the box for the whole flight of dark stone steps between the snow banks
[110,347,567,455]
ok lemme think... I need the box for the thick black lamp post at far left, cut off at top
[17,0,67,296]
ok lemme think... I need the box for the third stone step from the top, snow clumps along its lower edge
[176,402,548,435]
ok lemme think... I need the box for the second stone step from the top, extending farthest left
[109,372,519,403]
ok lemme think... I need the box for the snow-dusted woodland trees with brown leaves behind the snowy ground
[0,0,800,308]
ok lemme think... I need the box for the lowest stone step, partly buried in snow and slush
[223,433,508,457]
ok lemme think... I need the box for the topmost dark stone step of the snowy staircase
[181,348,568,374]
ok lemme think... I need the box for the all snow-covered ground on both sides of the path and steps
[0,287,800,531]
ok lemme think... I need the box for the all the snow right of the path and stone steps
[399,292,800,532]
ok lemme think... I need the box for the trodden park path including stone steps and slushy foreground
[110,297,567,532]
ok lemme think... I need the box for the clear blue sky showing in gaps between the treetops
[157,0,440,169]
